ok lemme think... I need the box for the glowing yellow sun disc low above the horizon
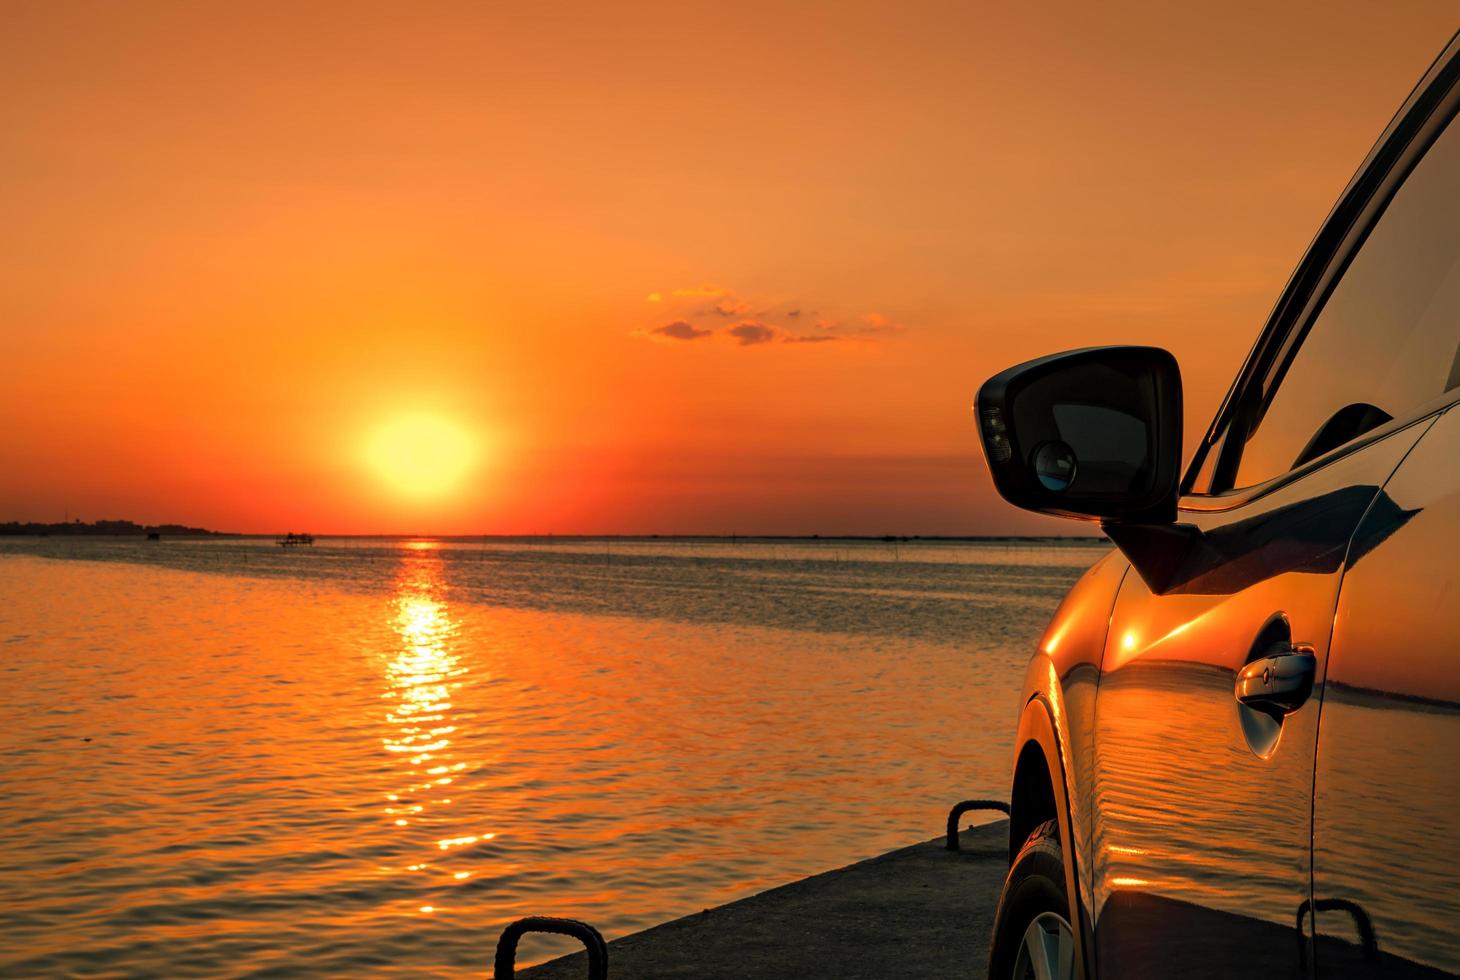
[365,412,477,499]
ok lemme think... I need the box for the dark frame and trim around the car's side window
[1178,32,1460,511]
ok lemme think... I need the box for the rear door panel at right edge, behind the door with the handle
[1310,409,1460,979]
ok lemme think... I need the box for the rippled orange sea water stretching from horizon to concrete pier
[0,537,1104,977]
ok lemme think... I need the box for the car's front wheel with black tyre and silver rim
[988,821,1076,980]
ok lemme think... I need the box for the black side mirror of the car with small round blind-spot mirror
[977,348,1181,524]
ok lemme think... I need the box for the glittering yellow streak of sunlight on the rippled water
[381,542,484,914]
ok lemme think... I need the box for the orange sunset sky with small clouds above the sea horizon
[0,0,1457,535]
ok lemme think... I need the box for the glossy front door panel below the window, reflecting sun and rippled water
[1091,428,1418,977]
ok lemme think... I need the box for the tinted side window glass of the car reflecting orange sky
[1235,108,1460,486]
